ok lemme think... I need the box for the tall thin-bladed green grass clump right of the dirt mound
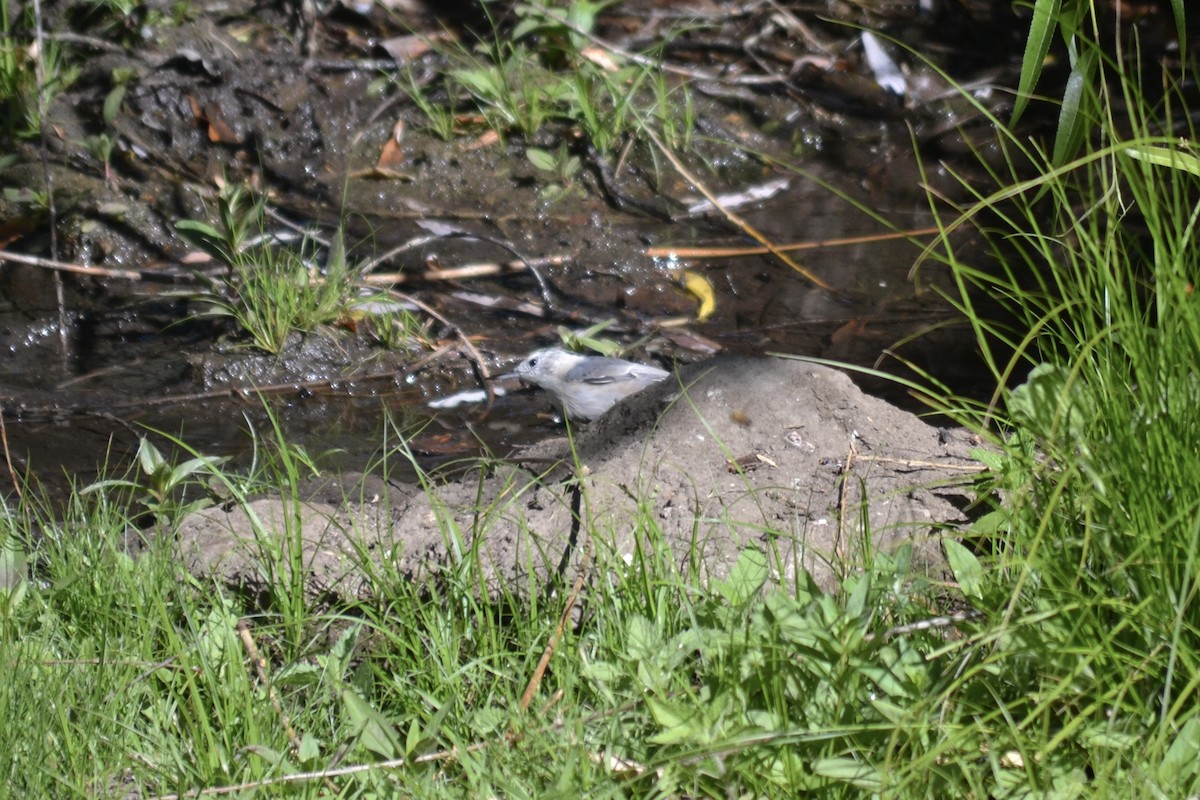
[925,21,1200,796]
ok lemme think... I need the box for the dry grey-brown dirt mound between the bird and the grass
[179,357,977,597]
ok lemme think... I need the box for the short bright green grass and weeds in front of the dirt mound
[0,417,988,796]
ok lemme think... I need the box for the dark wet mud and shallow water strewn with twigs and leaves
[0,1,1041,496]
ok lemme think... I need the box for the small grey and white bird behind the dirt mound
[504,348,671,420]
